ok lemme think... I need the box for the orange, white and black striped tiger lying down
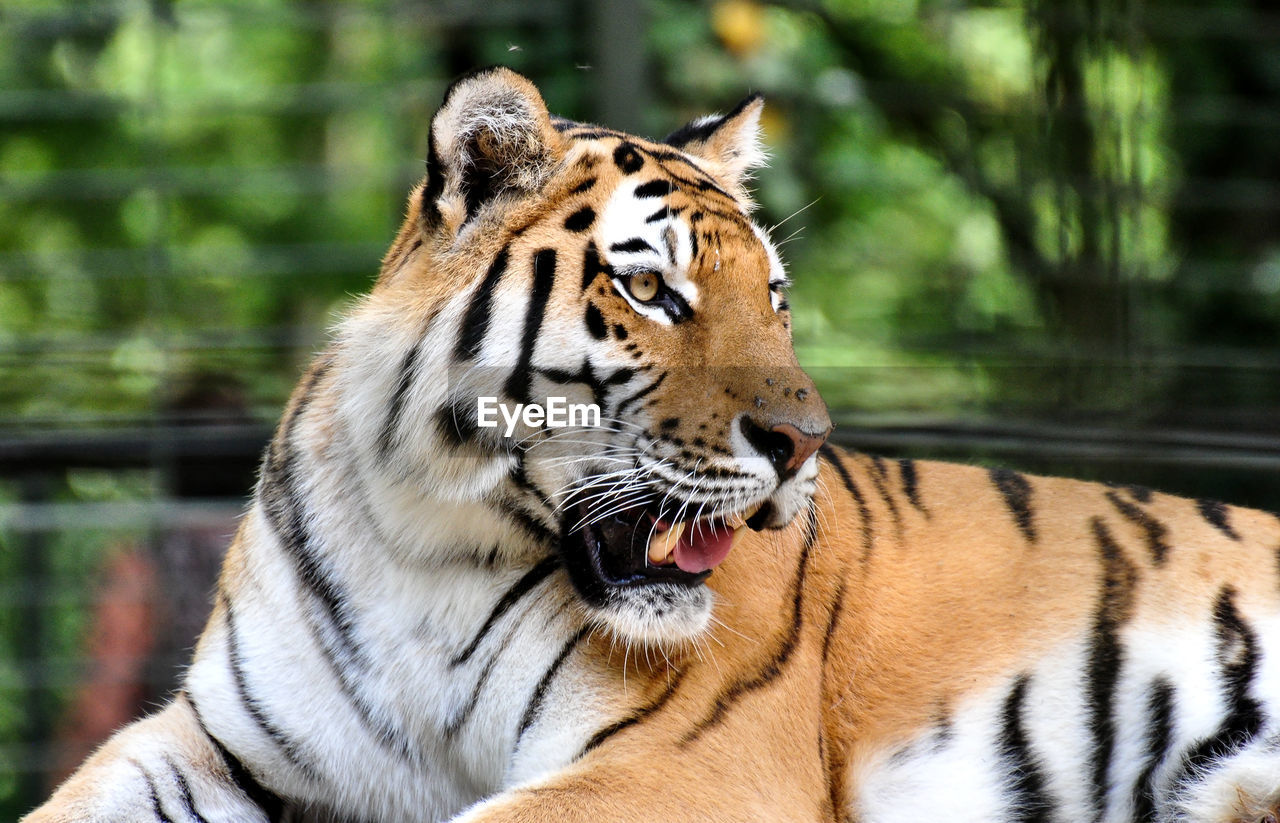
[26,68,1280,823]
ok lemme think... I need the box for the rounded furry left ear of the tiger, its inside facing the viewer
[421,67,563,233]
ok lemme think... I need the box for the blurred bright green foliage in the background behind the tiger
[0,0,1280,819]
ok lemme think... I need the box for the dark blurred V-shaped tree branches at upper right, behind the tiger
[774,0,1141,349]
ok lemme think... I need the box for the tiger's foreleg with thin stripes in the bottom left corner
[23,695,274,823]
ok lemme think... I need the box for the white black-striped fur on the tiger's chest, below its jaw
[188,501,607,820]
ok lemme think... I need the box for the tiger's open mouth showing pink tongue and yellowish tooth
[561,494,769,603]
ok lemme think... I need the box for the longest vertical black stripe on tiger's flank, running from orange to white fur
[1084,517,1138,819]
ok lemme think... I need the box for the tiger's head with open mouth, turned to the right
[346,68,831,643]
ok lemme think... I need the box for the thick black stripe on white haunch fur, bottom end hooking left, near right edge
[1174,586,1266,788]
